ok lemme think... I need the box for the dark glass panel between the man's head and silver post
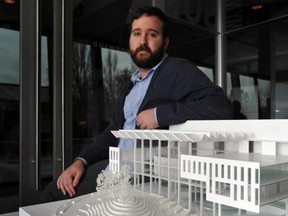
[161,0,217,66]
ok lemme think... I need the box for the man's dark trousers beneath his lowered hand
[42,160,109,202]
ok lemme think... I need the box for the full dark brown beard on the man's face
[129,43,165,69]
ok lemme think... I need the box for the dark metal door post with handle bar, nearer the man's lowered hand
[53,0,73,179]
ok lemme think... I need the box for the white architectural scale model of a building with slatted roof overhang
[56,120,288,216]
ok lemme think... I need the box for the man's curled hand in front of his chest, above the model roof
[136,108,158,129]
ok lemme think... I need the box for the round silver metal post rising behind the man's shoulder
[215,0,227,93]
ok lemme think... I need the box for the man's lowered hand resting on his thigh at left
[57,160,85,197]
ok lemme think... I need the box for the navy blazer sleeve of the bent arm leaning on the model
[154,59,232,127]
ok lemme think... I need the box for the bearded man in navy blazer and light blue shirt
[42,6,232,201]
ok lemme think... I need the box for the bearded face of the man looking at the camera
[129,15,168,69]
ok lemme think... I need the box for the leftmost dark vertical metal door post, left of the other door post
[19,0,41,206]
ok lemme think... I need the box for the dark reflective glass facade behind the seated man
[0,0,288,214]
